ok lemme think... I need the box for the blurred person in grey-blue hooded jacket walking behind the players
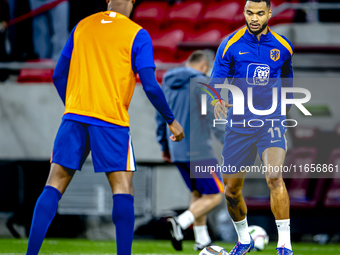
[156,51,224,250]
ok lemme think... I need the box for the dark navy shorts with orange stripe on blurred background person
[175,159,224,195]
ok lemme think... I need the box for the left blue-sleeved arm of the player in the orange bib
[53,25,76,104]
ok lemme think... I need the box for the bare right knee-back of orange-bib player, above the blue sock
[106,171,134,196]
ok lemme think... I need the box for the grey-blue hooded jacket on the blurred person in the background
[156,67,225,162]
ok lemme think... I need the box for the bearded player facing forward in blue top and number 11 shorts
[208,0,293,255]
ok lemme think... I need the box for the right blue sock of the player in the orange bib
[112,194,135,255]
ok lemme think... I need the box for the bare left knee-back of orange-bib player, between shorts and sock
[46,163,76,194]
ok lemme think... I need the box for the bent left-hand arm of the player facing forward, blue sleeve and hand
[207,39,232,119]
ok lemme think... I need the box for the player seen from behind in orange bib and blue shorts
[27,0,184,255]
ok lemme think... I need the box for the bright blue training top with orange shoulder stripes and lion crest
[208,27,293,134]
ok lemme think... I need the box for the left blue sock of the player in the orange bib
[27,186,61,255]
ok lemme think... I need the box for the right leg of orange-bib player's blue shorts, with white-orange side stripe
[88,125,136,172]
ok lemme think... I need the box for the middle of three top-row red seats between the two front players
[165,1,203,29]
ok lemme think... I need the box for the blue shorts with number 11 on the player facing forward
[222,123,287,174]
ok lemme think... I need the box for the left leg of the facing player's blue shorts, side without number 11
[222,128,257,175]
